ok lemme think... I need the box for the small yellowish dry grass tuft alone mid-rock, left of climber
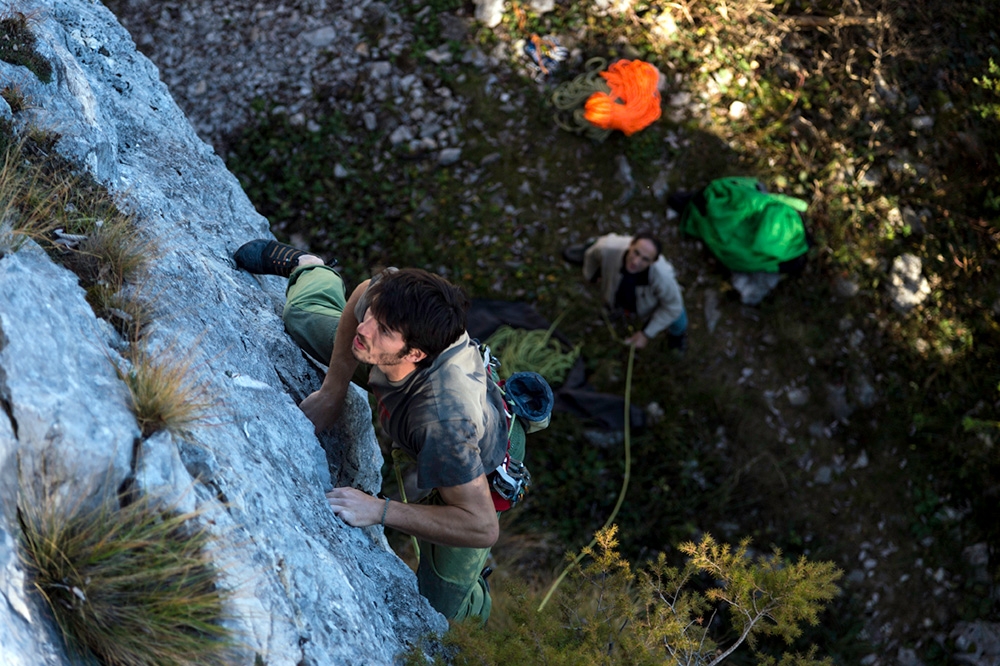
[115,343,213,437]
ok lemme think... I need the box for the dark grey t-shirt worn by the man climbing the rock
[355,274,507,490]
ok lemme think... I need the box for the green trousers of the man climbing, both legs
[282,265,524,622]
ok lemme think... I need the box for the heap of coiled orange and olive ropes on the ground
[552,58,661,141]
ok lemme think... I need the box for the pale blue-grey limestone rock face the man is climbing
[0,0,447,665]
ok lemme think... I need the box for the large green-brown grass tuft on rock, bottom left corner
[17,482,234,666]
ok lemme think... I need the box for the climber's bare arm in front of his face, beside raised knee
[299,280,371,434]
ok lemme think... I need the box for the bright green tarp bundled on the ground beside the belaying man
[681,177,809,273]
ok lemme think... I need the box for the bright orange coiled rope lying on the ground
[583,60,660,136]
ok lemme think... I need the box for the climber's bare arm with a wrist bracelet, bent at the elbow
[326,474,500,548]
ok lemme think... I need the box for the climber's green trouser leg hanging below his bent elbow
[417,421,524,624]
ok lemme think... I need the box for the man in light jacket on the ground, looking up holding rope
[563,231,687,352]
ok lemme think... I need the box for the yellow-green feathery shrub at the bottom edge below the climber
[408,526,841,666]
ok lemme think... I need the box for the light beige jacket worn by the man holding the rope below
[583,234,684,339]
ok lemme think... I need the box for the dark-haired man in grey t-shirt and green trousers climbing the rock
[234,240,524,622]
